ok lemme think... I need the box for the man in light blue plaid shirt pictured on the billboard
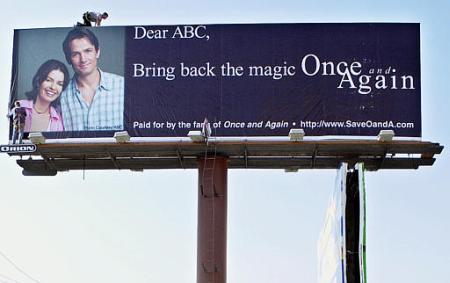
[61,27,124,131]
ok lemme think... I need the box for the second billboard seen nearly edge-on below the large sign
[317,163,367,283]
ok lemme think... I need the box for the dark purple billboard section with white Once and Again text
[125,24,421,137]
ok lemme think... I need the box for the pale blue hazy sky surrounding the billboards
[0,0,450,283]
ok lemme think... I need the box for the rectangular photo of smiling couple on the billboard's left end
[10,27,124,138]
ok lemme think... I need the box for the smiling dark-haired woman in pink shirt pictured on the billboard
[19,59,69,133]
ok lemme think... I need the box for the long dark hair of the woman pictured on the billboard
[25,59,69,108]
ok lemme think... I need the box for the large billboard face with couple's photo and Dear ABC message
[10,23,421,138]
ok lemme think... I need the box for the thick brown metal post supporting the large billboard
[197,156,228,283]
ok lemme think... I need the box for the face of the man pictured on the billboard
[69,37,100,76]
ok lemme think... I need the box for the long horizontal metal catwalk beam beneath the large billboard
[11,140,443,175]
